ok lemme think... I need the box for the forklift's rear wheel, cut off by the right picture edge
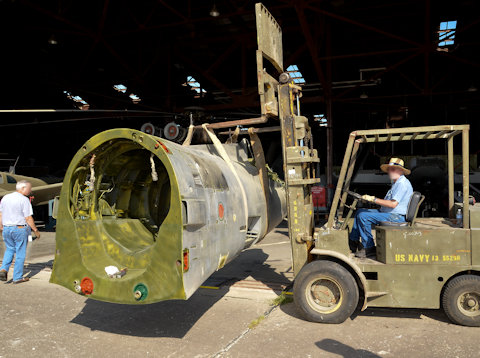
[442,275,480,327]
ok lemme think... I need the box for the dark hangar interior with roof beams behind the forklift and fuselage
[0,0,480,215]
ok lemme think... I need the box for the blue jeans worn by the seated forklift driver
[350,209,405,249]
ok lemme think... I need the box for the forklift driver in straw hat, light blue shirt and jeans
[349,158,413,259]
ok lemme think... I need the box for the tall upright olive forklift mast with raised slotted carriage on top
[255,3,320,275]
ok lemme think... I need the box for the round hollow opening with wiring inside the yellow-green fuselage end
[70,140,171,252]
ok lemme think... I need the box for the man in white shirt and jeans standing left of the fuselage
[0,180,40,283]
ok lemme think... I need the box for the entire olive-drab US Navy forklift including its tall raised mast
[256,4,480,326]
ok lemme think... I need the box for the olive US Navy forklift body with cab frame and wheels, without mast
[288,125,480,326]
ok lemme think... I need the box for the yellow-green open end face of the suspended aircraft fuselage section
[51,129,185,304]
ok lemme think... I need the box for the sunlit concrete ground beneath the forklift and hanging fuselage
[0,228,480,358]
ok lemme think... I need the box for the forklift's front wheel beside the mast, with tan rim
[293,260,359,323]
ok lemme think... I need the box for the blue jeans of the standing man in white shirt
[0,226,29,281]
